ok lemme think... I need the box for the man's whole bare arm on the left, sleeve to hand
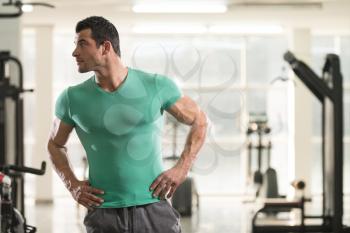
[47,118,103,209]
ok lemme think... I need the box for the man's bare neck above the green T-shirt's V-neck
[95,58,128,92]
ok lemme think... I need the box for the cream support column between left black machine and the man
[33,25,53,203]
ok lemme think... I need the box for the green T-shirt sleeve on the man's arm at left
[55,89,75,126]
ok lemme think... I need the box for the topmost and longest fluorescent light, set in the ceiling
[132,2,227,13]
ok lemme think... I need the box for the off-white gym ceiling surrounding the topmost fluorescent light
[0,0,350,30]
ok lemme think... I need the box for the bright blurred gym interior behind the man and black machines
[0,0,350,233]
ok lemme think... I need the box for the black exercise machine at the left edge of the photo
[0,51,45,233]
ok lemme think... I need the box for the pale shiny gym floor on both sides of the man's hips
[26,196,349,233]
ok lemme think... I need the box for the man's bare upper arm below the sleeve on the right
[166,96,201,125]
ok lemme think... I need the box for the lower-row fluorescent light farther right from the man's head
[209,24,283,34]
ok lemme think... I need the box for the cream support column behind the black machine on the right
[288,28,313,196]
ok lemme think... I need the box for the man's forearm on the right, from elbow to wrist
[177,111,208,171]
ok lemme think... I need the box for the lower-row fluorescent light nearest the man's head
[132,24,207,34]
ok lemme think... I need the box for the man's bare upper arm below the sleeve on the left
[49,117,74,147]
